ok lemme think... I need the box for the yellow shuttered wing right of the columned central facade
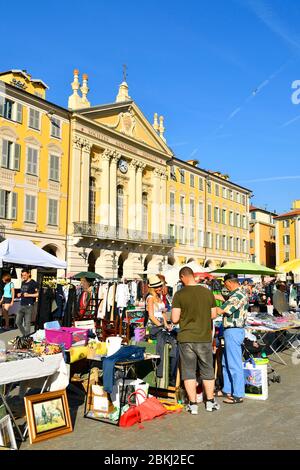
[168,157,251,267]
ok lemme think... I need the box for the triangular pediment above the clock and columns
[77,101,172,156]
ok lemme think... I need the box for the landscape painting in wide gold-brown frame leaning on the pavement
[24,390,73,444]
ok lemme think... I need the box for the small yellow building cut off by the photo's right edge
[275,200,300,265]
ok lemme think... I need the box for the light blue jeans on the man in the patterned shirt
[222,328,245,397]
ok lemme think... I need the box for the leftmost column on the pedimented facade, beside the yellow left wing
[69,136,81,225]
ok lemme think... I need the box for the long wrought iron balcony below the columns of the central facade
[73,222,175,246]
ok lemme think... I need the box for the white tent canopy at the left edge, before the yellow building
[0,238,67,269]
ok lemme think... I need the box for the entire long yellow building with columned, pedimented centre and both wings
[0,70,251,278]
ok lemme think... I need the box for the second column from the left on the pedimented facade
[80,140,92,222]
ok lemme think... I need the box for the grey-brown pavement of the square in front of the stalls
[0,328,300,450]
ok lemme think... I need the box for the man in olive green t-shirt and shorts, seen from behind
[171,267,220,414]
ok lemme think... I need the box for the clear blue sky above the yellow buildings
[0,0,300,212]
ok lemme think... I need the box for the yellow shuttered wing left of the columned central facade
[0,70,70,268]
